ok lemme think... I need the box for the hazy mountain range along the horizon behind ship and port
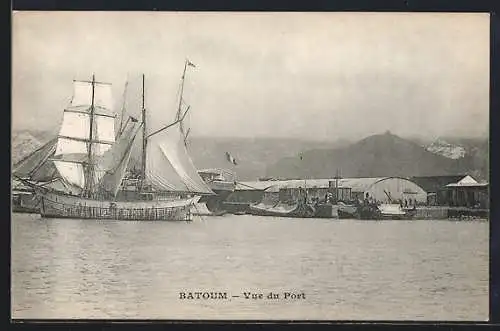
[12,130,489,180]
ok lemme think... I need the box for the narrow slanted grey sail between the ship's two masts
[96,119,141,196]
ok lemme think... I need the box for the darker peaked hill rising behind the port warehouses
[266,132,488,179]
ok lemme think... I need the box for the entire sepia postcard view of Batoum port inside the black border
[11,11,490,321]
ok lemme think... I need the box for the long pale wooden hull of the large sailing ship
[39,192,199,221]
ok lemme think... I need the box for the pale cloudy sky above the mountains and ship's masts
[12,12,489,140]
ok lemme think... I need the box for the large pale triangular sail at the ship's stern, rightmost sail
[146,122,214,194]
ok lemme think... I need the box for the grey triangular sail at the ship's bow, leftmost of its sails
[12,139,57,182]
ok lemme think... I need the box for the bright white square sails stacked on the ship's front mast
[53,81,115,189]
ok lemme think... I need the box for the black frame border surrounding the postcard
[7,0,500,330]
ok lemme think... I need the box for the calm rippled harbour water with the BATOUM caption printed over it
[11,214,489,320]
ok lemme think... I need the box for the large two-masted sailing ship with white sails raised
[19,65,214,221]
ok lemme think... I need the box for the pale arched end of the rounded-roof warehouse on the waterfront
[364,177,427,204]
